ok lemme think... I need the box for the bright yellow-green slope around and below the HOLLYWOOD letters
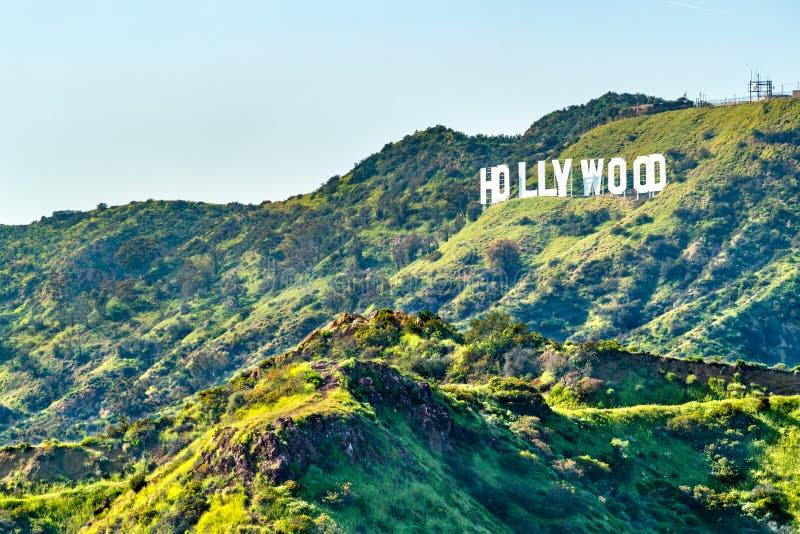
[398,99,800,365]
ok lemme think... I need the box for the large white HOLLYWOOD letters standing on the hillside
[480,154,667,205]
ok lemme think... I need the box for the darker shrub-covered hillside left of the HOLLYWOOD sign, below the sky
[0,127,516,442]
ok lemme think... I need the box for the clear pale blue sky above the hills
[0,0,800,223]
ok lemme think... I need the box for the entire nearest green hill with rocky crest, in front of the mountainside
[0,310,800,532]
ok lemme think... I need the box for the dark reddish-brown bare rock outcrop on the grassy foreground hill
[196,361,458,490]
